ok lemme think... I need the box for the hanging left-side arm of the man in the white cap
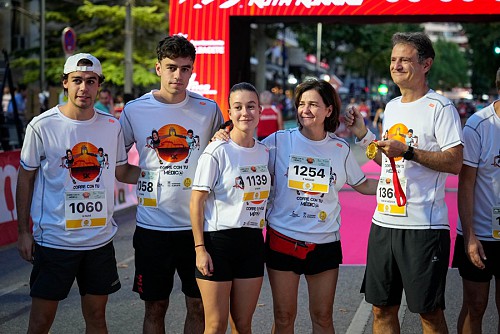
[16,166,37,262]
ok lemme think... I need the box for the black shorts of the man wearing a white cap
[30,242,121,301]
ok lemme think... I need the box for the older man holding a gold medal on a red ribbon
[346,32,463,334]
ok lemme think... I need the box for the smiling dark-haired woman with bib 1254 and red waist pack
[211,79,378,334]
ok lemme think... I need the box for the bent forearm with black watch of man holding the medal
[377,139,464,175]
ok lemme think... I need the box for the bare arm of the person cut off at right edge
[457,165,486,269]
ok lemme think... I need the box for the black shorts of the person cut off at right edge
[452,234,500,282]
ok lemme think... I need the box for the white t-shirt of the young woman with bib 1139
[193,140,271,232]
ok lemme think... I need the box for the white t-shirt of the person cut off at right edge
[457,100,500,241]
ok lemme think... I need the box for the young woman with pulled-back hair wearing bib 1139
[190,82,271,334]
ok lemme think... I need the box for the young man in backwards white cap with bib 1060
[16,53,140,333]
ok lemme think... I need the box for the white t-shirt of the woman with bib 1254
[263,128,366,244]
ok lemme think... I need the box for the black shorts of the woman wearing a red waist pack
[266,238,342,275]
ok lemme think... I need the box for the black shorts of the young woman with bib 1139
[196,227,264,282]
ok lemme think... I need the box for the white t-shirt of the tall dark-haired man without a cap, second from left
[120,91,224,231]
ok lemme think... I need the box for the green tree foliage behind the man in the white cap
[11,0,168,94]
